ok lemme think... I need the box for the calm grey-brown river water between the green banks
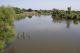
[5,15,80,53]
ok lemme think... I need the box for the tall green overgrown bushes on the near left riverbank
[0,6,15,49]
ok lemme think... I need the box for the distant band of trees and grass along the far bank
[14,7,80,20]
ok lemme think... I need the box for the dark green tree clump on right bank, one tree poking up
[52,7,80,19]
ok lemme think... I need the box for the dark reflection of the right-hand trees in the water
[51,17,80,28]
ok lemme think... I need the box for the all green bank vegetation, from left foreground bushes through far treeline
[0,6,80,50]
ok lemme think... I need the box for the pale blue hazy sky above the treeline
[0,0,80,10]
